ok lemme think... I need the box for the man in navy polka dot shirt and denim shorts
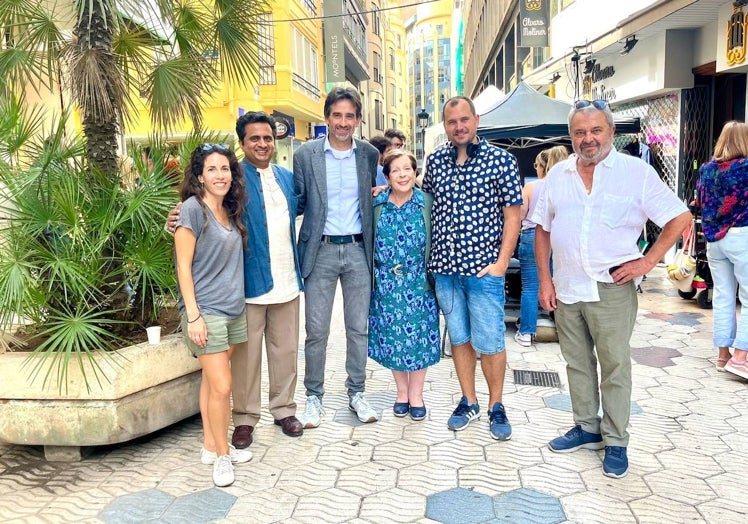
[423,96,522,440]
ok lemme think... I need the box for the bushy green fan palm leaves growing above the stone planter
[0,97,184,389]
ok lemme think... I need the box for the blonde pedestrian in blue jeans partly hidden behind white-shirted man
[514,146,569,347]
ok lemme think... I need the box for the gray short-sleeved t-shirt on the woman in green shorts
[177,196,244,317]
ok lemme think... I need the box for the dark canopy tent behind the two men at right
[478,82,640,148]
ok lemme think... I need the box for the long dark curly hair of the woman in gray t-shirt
[179,144,247,247]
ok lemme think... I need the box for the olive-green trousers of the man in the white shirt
[556,282,638,446]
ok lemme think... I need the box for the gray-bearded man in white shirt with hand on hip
[532,100,691,478]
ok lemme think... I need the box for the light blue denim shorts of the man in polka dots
[434,274,505,355]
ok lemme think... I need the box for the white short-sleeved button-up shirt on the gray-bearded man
[532,150,687,304]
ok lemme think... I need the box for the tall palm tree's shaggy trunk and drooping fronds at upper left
[0,0,270,176]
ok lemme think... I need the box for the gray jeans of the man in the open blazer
[304,242,371,398]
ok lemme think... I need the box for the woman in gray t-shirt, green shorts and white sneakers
[174,144,252,486]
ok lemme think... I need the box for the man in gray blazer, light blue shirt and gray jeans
[293,87,379,428]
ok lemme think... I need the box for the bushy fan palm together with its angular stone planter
[0,100,231,459]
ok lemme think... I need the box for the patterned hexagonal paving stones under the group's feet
[0,268,748,524]
